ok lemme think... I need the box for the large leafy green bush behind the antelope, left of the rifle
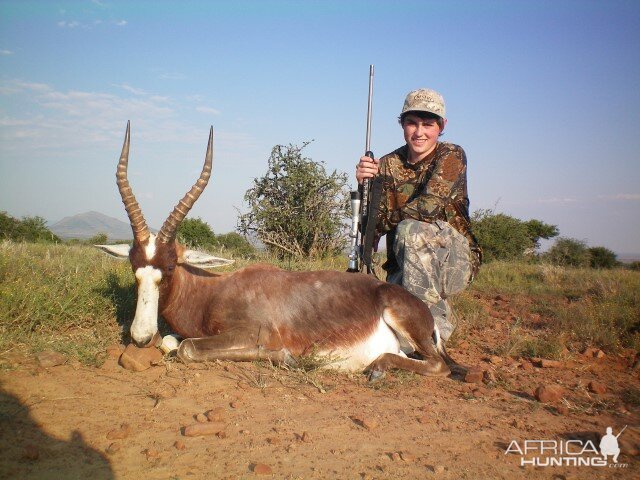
[238,142,350,258]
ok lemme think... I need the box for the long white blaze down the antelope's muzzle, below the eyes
[131,265,162,344]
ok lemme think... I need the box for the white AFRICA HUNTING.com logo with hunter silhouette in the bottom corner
[504,425,628,468]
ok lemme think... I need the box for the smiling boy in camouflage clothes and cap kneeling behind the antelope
[356,89,482,342]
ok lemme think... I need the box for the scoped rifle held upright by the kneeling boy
[347,65,382,275]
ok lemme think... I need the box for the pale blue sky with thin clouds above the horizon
[0,0,640,255]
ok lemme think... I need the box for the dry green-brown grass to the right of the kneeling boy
[464,262,640,358]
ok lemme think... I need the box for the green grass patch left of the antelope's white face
[0,242,135,363]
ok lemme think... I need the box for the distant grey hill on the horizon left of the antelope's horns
[49,212,133,242]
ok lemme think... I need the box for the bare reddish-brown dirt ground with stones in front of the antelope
[0,298,640,479]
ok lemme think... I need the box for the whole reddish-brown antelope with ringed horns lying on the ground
[100,124,450,379]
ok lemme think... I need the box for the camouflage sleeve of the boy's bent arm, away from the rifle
[398,145,469,222]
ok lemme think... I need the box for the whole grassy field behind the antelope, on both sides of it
[0,242,640,364]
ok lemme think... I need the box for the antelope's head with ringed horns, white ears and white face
[96,122,232,346]
